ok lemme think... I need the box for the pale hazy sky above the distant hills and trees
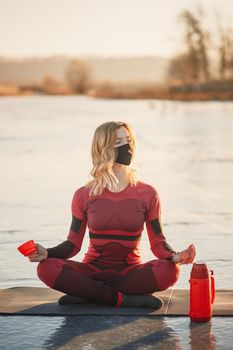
[0,0,233,58]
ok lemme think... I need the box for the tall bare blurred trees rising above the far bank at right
[168,9,233,83]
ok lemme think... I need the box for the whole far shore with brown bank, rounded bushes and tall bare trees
[0,8,233,100]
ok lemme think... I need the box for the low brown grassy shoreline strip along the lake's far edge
[0,80,233,101]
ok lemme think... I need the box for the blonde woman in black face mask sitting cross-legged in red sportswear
[29,122,195,309]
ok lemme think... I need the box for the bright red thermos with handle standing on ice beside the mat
[189,262,215,322]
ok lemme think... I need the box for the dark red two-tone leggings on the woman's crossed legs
[37,258,180,305]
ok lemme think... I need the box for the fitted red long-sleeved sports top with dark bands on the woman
[62,181,176,266]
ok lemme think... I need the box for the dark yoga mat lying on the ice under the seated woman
[0,287,233,316]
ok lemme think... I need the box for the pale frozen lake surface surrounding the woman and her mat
[0,96,233,350]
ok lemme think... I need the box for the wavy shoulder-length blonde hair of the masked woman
[85,122,138,195]
